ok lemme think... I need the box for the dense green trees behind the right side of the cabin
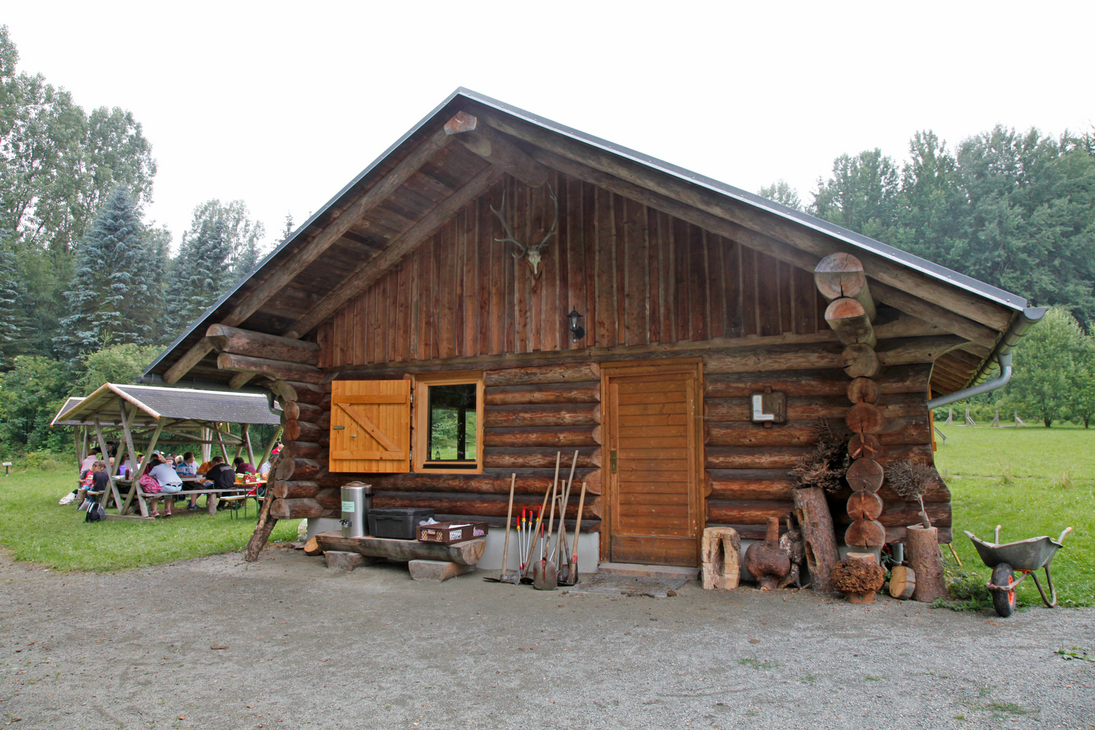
[760,126,1095,427]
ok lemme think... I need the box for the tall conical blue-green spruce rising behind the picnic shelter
[59,187,159,357]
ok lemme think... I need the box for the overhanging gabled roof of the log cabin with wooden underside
[146,89,1026,393]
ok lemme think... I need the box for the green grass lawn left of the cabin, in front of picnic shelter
[0,467,299,571]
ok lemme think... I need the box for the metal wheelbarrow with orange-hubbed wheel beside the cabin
[966,524,1072,616]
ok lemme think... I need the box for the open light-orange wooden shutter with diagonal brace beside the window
[330,380,411,474]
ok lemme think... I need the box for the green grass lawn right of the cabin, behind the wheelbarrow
[935,426,1095,606]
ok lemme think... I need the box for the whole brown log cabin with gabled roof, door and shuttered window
[146,89,1040,566]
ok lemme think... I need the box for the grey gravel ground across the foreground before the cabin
[0,547,1095,730]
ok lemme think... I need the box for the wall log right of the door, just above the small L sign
[704,364,931,398]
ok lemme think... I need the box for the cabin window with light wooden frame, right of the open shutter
[414,372,483,473]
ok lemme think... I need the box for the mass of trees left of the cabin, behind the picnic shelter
[0,26,278,456]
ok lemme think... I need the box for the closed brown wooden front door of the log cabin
[602,361,703,566]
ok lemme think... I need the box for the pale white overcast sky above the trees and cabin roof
[0,0,1095,253]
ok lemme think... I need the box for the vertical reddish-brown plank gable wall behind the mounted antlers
[318,172,828,369]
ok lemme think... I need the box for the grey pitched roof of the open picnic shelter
[50,383,281,426]
